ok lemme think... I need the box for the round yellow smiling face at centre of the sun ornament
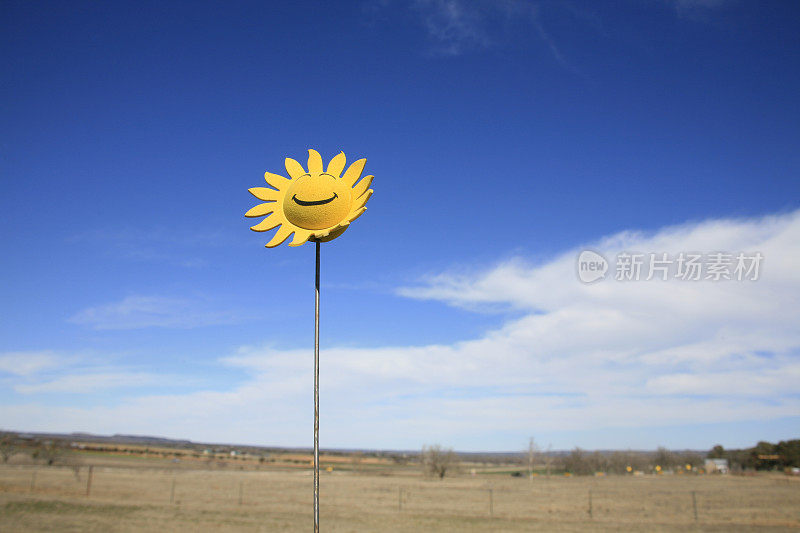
[283,172,352,229]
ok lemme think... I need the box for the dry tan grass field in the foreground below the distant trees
[0,457,800,532]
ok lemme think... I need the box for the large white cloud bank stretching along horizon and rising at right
[0,211,800,449]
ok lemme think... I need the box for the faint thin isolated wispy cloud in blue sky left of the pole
[70,296,237,330]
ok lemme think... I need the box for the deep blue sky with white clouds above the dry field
[0,0,800,450]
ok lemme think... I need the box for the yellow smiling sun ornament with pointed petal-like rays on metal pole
[244,150,373,248]
